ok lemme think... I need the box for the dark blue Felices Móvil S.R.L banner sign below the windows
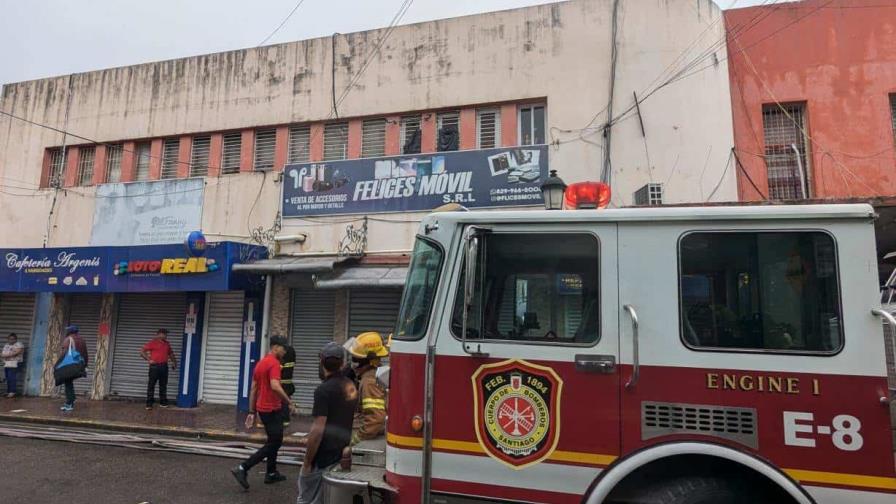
[282,145,548,217]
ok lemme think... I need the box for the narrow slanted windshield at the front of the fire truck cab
[393,238,443,340]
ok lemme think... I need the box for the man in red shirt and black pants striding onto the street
[230,336,290,490]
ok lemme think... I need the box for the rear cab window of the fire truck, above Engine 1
[679,232,843,353]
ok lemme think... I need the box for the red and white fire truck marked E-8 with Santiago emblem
[326,194,896,504]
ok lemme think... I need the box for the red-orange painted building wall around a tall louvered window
[725,0,896,201]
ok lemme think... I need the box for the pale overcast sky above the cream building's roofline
[0,0,759,84]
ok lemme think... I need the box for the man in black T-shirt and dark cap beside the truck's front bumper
[296,342,358,504]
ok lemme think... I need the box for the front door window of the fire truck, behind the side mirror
[451,233,600,344]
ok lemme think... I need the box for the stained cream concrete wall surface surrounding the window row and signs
[0,0,736,251]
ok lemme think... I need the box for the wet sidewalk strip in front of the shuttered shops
[0,397,311,444]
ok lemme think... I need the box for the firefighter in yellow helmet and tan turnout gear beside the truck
[345,332,389,445]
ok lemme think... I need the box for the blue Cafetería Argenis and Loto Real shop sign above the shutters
[0,242,266,293]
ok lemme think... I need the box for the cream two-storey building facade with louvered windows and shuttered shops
[0,0,737,407]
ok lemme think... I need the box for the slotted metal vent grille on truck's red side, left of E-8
[641,402,759,449]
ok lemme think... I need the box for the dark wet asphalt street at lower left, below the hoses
[0,437,299,504]
